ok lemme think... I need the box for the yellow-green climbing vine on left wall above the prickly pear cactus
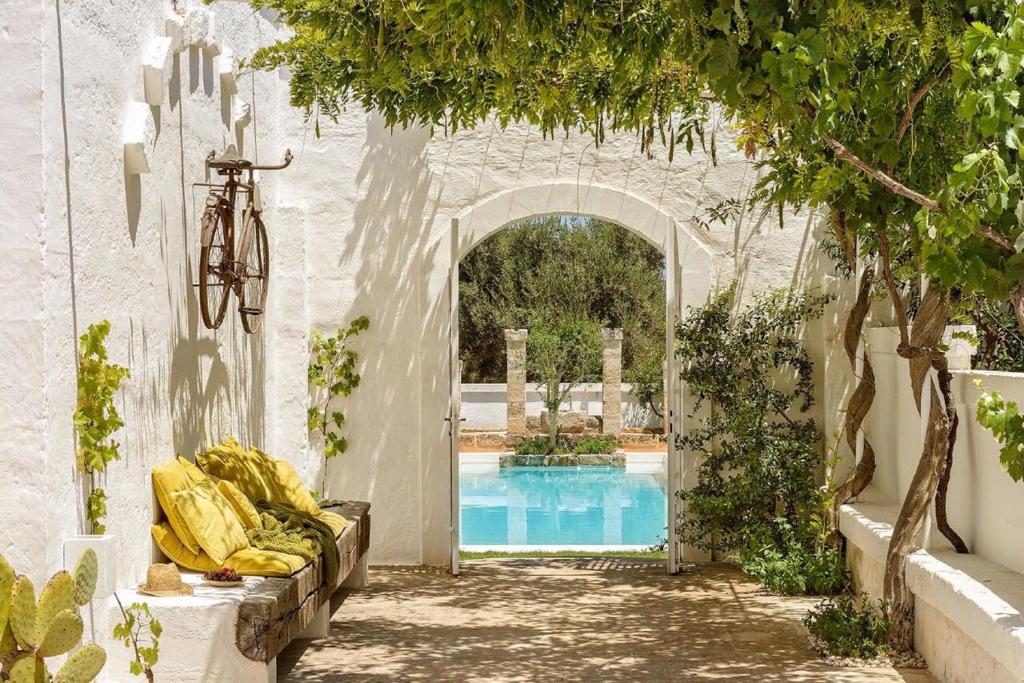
[73,321,130,533]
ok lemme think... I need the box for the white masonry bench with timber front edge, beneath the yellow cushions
[101,502,370,683]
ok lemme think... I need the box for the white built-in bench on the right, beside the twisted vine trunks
[840,503,1024,683]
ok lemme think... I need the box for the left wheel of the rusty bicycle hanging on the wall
[199,195,234,330]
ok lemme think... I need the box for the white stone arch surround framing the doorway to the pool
[423,181,715,571]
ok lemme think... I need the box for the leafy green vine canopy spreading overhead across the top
[253,0,1024,315]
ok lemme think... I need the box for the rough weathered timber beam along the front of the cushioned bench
[236,501,370,663]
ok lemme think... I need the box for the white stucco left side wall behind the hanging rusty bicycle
[0,1,284,585]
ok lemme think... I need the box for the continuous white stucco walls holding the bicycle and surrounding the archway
[0,0,825,585]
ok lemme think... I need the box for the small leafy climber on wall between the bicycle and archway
[307,315,370,459]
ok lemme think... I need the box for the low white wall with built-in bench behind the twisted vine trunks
[840,328,1024,683]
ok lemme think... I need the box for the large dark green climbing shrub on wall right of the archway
[676,288,828,552]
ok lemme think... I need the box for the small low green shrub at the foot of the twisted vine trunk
[804,593,893,659]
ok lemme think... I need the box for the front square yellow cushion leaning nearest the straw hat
[171,480,249,564]
